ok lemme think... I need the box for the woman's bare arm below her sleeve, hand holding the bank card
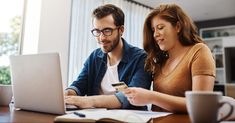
[125,75,215,113]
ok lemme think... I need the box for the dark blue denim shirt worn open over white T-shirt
[67,39,152,109]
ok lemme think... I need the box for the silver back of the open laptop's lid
[10,53,73,114]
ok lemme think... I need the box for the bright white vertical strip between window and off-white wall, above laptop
[21,0,41,54]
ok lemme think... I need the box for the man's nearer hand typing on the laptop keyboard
[65,96,93,108]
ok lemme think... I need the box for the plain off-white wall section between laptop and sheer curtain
[38,0,71,83]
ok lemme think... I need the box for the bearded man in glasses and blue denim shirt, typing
[65,4,151,109]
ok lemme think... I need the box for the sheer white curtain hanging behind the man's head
[68,0,151,85]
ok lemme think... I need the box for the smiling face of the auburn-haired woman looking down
[151,16,180,51]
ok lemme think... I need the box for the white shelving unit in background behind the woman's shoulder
[200,25,235,85]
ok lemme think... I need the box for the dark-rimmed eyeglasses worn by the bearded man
[91,27,119,37]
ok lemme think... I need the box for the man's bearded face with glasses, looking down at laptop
[93,15,122,53]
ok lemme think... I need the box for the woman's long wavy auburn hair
[143,4,203,75]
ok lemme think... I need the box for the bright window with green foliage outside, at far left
[0,0,24,84]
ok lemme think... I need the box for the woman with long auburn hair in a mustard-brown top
[124,4,215,113]
